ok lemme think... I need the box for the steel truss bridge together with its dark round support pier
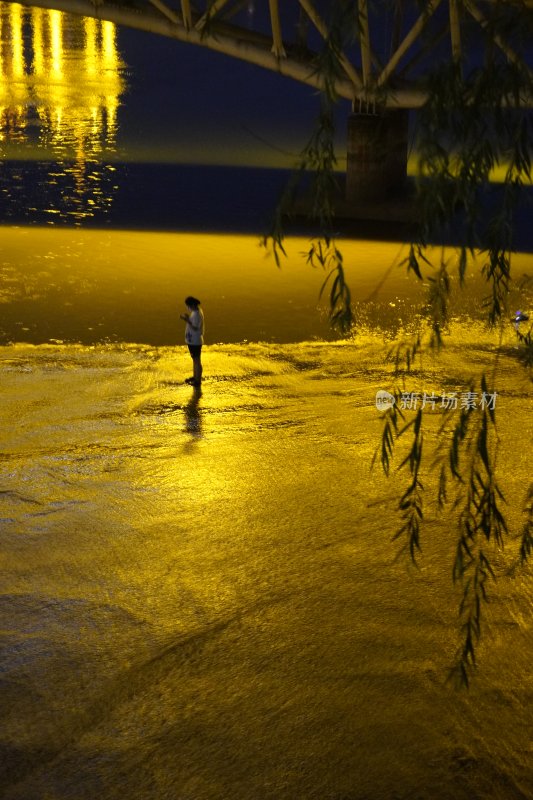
[7,0,533,203]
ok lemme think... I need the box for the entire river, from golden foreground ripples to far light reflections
[0,3,533,800]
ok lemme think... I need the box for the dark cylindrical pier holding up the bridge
[346,109,409,205]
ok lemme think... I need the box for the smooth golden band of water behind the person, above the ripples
[0,227,533,348]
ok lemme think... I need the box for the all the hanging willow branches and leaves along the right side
[264,0,533,686]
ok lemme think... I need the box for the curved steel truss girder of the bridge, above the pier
[8,0,533,108]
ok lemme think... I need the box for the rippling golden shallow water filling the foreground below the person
[0,327,533,800]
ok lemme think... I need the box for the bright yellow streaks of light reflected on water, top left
[0,3,125,221]
